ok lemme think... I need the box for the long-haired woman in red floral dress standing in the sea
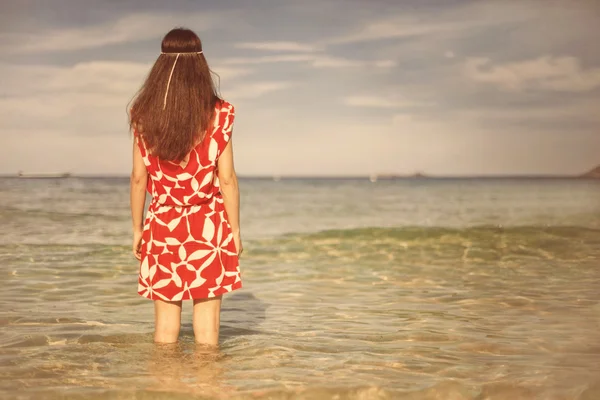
[130,29,242,345]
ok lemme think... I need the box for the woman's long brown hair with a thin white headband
[129,28,220,161]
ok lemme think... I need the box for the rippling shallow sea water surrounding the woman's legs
[0,178,600,400]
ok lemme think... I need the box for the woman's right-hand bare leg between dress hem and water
[193,295,223,346]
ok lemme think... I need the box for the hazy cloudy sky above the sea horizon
[0,0,600,176]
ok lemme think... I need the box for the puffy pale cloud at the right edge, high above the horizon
[464,56,600,92]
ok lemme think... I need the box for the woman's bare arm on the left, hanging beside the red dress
[129,137,148,260]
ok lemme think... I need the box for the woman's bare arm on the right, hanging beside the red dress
[217,140,243,255]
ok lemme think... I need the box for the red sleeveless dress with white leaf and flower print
[134,101,242,301]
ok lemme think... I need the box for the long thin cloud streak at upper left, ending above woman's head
[0,13,222,54]
